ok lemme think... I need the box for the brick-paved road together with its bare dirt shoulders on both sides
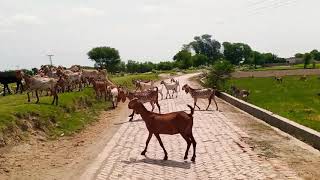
[0,75,320,180]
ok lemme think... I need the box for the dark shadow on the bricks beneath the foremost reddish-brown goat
[121,156,191,169]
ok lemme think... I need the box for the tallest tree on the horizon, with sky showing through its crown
[183,34,221,63]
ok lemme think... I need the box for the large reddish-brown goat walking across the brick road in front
[128,99,197,162]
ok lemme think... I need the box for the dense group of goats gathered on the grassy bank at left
[0,65,124,107]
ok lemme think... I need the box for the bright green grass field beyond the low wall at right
[228,76,320,132]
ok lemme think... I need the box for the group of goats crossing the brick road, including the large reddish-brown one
[127,78,222,162]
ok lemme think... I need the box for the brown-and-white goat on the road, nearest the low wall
[182,84,218,111]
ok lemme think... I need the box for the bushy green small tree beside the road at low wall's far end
[207,60,234,89]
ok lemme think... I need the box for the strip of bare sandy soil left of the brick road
[0,103,129,180]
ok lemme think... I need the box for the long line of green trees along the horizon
[88,34,320,73]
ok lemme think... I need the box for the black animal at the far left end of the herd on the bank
[0,70,23,96]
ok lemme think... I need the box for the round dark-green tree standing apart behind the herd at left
[87,46,120,73]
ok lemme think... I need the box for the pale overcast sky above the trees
[0,0,320,70]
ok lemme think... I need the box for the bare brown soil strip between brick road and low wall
[192,77,320,179]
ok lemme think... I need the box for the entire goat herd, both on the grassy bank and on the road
[0,65,225,161]
